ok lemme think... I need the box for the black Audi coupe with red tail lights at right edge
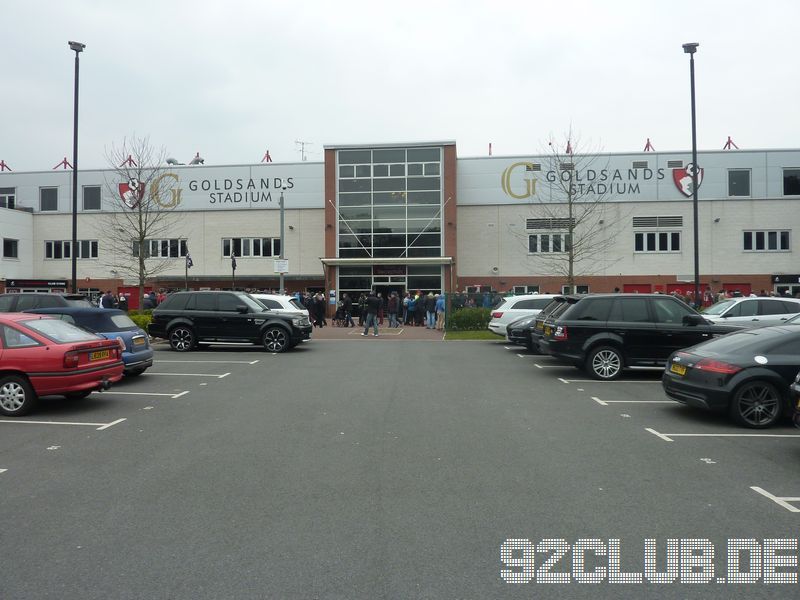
[661,325,800,428]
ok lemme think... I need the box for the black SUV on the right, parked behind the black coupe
[539,294,739,380]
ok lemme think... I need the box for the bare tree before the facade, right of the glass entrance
[512,131,625,293]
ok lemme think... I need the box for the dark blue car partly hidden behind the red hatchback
[25,306,153,375]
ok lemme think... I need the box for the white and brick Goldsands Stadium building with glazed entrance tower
[0,141,800,310]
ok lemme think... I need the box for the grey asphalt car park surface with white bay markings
[0,336,800,599]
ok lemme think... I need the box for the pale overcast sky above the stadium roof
[0,0,800,171]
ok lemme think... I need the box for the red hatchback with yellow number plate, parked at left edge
[0,313,123,417]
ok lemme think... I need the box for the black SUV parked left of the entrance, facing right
[147,292,311,352]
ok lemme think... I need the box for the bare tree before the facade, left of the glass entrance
[98,136,181,308]
